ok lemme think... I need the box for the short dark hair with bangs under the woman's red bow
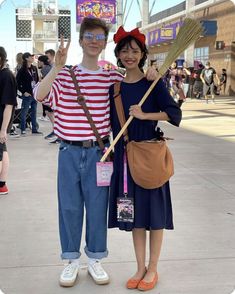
[114,36,148,71]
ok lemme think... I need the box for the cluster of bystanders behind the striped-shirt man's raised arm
[6,49,60,144]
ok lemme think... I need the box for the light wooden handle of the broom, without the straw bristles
[100,74,161,162]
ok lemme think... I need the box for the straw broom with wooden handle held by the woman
[100,18,203,162]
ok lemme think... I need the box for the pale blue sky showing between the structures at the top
[0,0,183,66]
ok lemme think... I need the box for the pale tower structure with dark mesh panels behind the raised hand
[16,0,71,54]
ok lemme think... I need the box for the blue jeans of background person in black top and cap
[20,96,37,133]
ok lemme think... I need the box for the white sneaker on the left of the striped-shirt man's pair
[60,262,79,287]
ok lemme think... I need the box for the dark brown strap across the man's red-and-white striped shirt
[69,68,105,150]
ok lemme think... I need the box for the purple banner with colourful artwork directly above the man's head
[76,0,116,24]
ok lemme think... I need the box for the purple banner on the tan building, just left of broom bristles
[148,21,183,46]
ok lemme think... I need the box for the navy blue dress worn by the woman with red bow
[108,78,182,231]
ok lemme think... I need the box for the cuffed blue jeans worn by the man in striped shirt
[58,141,108,259]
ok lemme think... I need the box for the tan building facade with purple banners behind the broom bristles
[141,0,235,95]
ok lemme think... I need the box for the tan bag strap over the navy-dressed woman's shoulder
[113,82,129,142]
